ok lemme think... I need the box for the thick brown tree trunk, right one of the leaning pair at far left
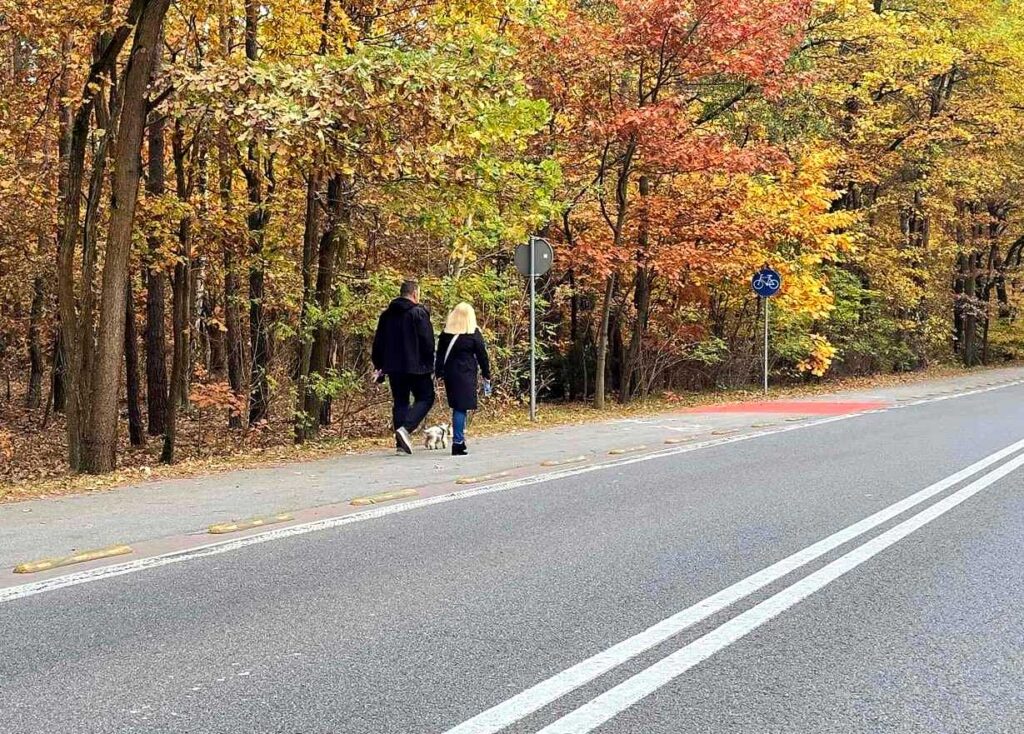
[81,0,170,473]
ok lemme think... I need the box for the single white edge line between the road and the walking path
[0,380,1024,604]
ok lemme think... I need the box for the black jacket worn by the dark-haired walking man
[373,298,434,375]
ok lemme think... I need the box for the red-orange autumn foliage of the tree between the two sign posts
[535,0,809,292]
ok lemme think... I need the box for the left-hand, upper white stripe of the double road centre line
[444,439,1024,734]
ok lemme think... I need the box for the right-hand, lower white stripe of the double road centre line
[538,446,1024,734]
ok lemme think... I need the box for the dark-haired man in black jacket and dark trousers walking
[373,280,434,454]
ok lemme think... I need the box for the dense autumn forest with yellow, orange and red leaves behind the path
[0,0,1024,473]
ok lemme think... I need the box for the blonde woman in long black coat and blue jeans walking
[434,303,490,457]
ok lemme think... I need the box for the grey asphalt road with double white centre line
[0,386,1024,734]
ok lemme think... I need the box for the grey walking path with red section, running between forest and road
[0,368,1024,569]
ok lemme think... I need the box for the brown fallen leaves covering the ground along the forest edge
[0,366,1007,502]
